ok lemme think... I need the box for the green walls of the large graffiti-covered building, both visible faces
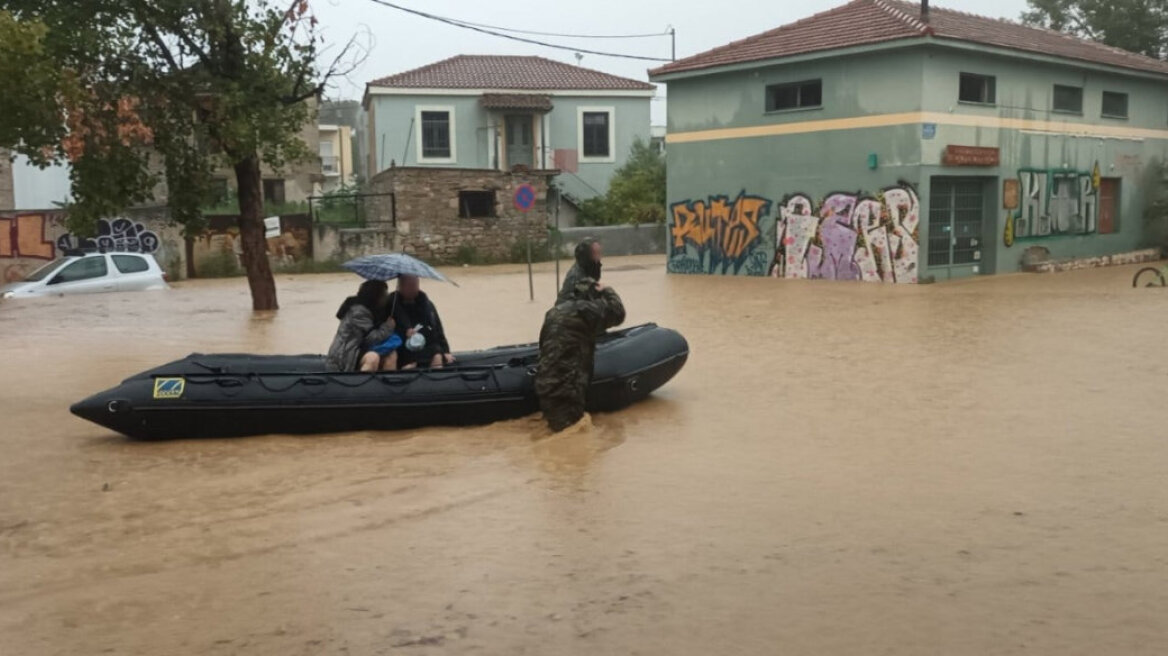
[667,46,1168,282]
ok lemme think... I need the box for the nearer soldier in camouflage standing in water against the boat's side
[535,277,625,432]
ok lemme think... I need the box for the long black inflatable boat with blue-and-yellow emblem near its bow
[70,324,689,439]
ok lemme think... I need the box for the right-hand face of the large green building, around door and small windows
[919,49,1168,278]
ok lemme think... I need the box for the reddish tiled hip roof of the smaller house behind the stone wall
[369,55,655,91]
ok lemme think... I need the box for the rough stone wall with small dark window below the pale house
[367,167,555,261]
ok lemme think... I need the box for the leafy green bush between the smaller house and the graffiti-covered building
[579,139,666,225]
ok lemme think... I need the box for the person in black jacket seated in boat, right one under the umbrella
[389,275,454,369]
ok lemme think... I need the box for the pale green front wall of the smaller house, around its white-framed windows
[367,95,649,200]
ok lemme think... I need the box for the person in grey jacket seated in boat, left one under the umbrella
[325,280,402,372]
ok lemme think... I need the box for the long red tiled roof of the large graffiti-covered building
[649,0,1168,75]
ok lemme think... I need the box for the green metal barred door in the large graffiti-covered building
[929,177,986,279]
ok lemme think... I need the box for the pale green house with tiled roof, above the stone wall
[363,55,654,208]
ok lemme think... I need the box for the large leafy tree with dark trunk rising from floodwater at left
[0,0,355,309]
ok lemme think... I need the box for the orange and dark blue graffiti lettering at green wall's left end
[669,190,772,275]
